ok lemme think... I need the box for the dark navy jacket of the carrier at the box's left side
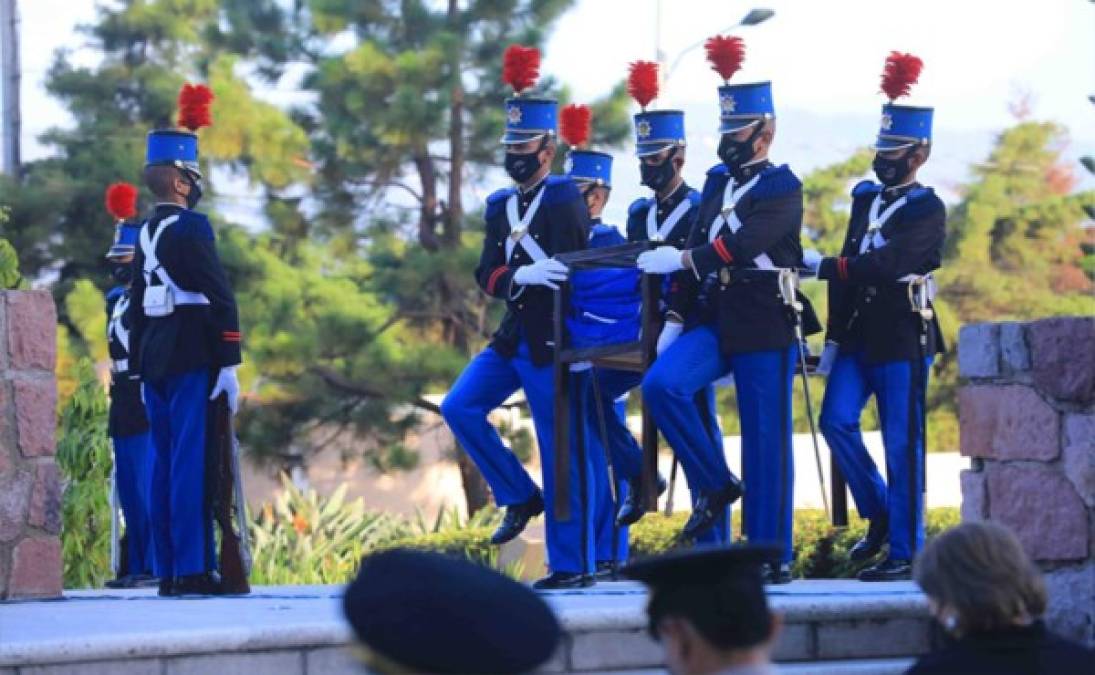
[475,175,589,366]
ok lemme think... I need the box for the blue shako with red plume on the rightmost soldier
[875,52,934,150]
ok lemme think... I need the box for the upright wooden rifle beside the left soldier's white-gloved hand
[206,394,251,595]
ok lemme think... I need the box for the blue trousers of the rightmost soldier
[820,354,932,560]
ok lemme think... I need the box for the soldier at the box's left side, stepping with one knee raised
[441,45,595,590]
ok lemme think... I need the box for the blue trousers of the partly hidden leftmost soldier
[112,432,154,574]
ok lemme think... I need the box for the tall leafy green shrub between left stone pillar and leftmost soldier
[57,358,113,588]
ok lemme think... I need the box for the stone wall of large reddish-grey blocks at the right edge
[958,317,1095,645]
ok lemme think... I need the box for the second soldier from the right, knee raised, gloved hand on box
[638,38,816,583]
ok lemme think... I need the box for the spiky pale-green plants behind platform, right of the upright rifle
[251,474,408,584]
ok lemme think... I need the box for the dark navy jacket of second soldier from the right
[670,162,821,355]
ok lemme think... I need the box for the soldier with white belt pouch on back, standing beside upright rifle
[127,85,241,595]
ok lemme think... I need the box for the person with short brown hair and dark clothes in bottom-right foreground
[909,523,1095,675]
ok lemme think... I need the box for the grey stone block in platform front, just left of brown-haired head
[817,618,931,660]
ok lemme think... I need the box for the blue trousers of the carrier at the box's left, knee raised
[441,340,596,573]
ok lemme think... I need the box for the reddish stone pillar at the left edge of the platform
[0,290,61,600]
